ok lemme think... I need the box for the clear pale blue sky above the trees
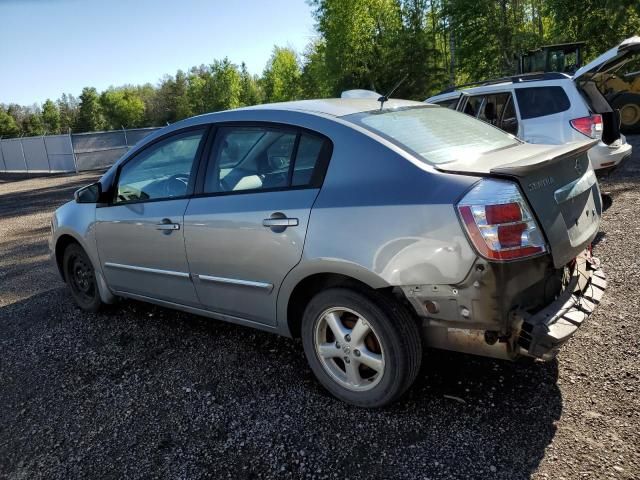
[0,0,315,105]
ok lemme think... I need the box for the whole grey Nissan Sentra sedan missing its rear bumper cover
[50,99,605,407]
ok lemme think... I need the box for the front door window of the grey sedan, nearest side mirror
[114,129,205,203]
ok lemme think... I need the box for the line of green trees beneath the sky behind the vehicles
[0,0,640,137]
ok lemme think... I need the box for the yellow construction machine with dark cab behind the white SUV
[518,37,640,133]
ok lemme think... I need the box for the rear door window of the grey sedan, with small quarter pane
[204,127,326,193]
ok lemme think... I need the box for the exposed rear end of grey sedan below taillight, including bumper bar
[403,250,606,360]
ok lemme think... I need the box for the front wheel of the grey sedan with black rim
[62,243,102,313]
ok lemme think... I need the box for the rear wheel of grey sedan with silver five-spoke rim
[301,288,422,408]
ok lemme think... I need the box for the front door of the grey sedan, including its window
[96,128,205,305]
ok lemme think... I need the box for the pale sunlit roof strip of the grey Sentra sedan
[236,98,424,117]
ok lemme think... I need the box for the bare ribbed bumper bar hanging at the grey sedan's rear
[514,251,607,360]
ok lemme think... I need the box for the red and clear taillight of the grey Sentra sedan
[457,179,546,260]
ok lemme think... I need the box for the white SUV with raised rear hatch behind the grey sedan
[425,37,640,173]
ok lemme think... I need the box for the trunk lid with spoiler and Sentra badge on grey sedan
[435,141,602,268]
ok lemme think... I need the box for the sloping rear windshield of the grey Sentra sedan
[344,105,520,164]
